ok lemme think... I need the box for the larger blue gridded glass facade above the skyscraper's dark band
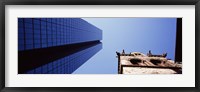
[18,18,102,51]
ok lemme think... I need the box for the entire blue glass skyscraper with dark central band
[18,18,102,74]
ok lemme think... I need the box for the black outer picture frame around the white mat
[0,0,200,92]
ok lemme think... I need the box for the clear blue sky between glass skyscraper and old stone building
[74,18,176,74]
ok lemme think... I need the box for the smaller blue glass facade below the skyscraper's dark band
[27,44,102,74]
